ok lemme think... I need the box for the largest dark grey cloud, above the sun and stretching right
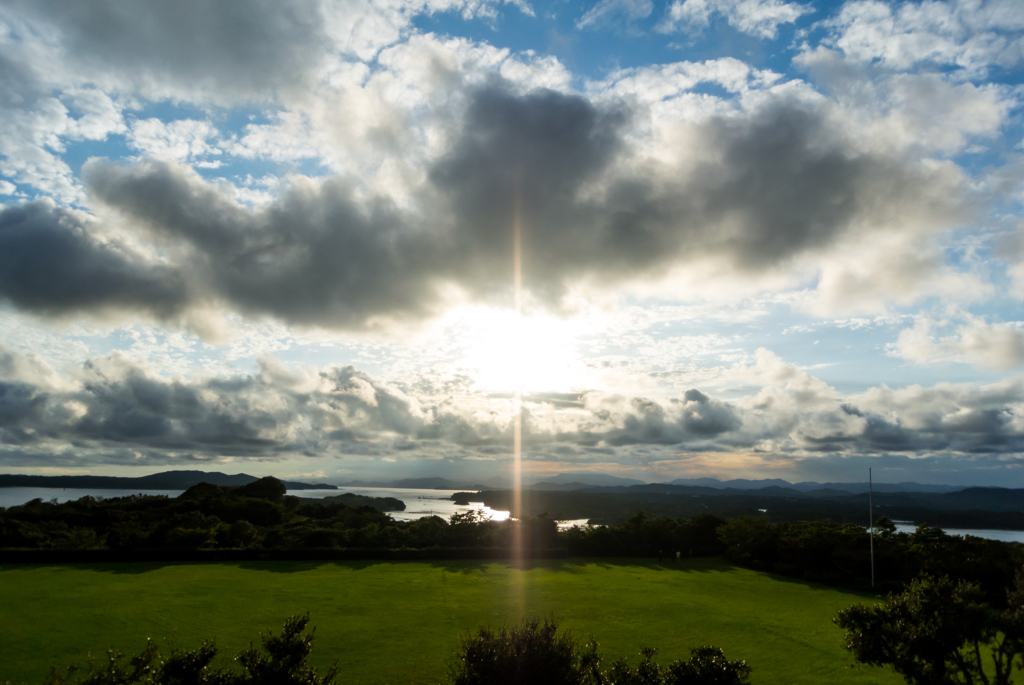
[431,85,955,294]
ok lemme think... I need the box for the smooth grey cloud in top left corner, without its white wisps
[2,0,330,97]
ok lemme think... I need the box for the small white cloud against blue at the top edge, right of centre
[656,0,814,40]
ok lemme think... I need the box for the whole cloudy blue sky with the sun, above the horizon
[0,0,1024,487]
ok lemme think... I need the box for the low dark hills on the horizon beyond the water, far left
[0,471,338,490]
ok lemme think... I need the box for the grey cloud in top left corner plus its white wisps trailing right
[4,0,532,103]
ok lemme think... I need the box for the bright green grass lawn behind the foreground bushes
[0,560,902,685]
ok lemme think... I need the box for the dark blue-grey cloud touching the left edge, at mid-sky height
[0,197,186,316]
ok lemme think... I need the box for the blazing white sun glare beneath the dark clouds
[459,308,586,392]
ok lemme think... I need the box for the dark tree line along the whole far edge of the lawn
[0,478,1024,604]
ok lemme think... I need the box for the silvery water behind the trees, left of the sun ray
[0,487,509,521]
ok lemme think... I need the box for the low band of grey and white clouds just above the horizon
[6,341,1024,480]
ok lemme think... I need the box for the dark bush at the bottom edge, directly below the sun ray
[449,618,751,685]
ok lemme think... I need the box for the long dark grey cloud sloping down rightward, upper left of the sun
[84,163,444,328]
